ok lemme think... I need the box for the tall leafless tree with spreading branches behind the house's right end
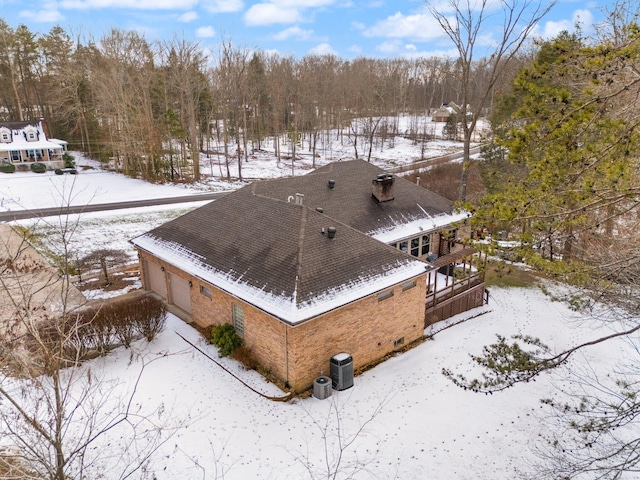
[428,0,556,201]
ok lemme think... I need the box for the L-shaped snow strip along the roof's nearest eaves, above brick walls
[131,234,431,325]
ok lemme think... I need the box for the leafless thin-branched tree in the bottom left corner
[0,202,179,480]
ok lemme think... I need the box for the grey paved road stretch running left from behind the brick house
[0,192,228,222]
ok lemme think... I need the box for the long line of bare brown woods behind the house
[0,19,510,181]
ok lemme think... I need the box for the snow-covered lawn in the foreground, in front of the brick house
[72,288,628,480]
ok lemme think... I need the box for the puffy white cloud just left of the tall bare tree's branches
[363,12,443,40]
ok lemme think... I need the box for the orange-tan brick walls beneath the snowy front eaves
[140,252,426,391]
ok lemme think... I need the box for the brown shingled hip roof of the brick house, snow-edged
[131,160,466,324]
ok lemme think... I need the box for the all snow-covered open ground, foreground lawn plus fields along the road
[0,119,637,480]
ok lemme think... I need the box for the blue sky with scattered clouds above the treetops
[0,0,613,59]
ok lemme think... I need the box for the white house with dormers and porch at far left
[0,119,67,168]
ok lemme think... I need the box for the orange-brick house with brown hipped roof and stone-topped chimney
[131,160,482,391]
